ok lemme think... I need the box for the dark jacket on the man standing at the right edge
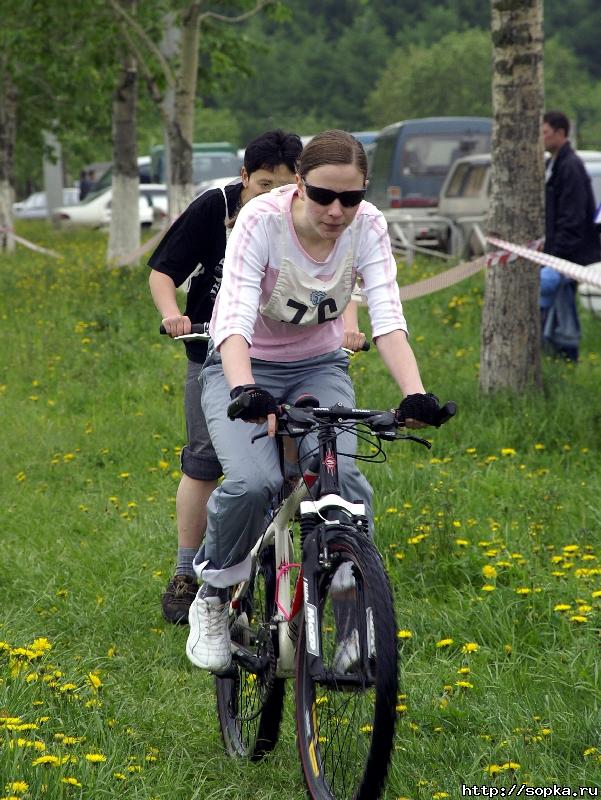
[545,142,601,265]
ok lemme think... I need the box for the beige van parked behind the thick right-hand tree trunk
[438,150,601,255]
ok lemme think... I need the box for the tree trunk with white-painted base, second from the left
[107,0,140,264]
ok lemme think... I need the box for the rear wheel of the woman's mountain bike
[215,547,285,761]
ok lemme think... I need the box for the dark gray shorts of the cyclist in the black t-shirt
[181,360,222,481]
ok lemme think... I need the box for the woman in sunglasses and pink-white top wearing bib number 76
[186,130,439,672]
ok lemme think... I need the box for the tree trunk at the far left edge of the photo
[0,72,17,253]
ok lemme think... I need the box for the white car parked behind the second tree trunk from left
[52,183,167,228]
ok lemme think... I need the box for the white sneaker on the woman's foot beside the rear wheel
[186,589,232,672]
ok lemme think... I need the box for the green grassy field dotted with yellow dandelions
[0,223,601,800]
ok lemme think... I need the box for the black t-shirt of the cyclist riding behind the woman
[148,183,242,363]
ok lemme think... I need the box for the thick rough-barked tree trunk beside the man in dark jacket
[480,0,545,392]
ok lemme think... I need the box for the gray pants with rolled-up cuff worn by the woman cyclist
[194,350,372,587]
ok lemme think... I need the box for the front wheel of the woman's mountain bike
[296,530,398,800]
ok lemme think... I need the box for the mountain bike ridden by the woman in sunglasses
[215,386,455,800]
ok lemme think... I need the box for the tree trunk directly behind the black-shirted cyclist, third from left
[167,4,199,217]
